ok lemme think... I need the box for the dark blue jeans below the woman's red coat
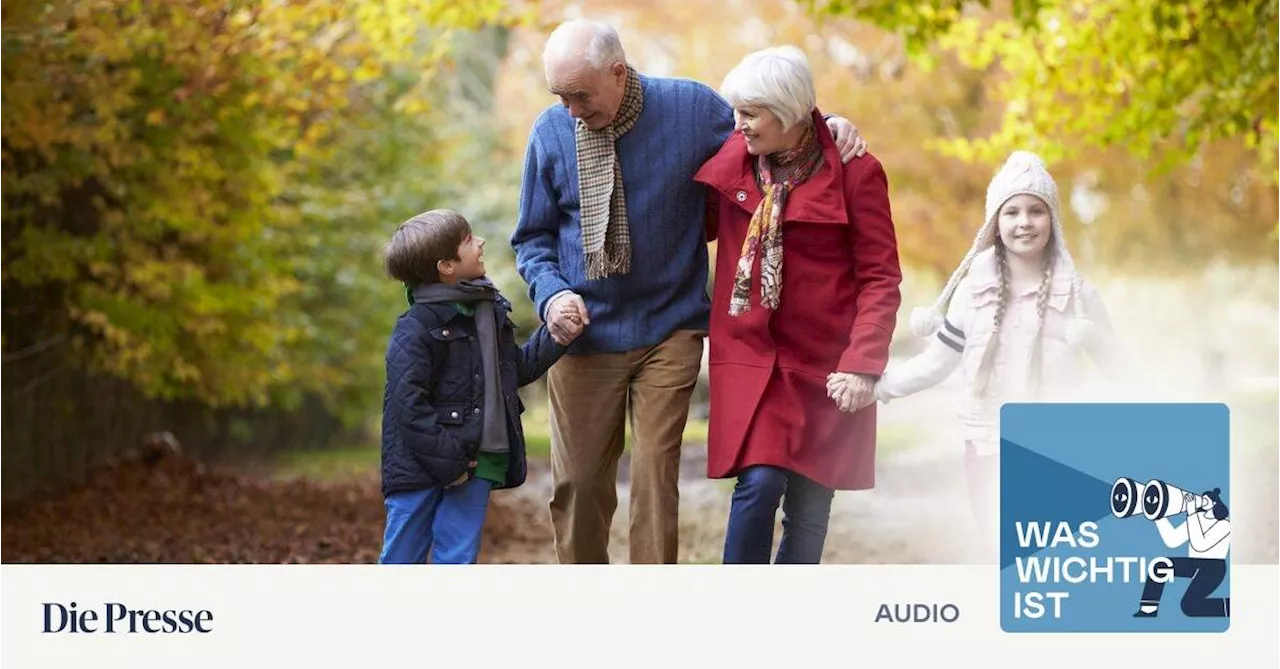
[724,466,836,564]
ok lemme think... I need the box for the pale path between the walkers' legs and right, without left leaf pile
[483,384,1280,564]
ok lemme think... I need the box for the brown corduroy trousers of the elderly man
[547,330,705,564]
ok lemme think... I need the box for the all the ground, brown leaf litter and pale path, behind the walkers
[0,383,1280,564]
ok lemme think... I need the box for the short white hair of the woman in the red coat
[721,46,818,130]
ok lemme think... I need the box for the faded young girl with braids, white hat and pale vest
[876,151,1112,550]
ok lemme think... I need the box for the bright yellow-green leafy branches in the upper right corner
[804,0,1280,177]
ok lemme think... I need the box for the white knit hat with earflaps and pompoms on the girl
[911,151,1092,344]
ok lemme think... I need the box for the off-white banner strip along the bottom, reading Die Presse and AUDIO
[0,565,1280,669]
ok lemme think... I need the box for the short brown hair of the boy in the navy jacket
[383,209,471,285]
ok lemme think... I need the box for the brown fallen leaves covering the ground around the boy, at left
[0,453,550,564]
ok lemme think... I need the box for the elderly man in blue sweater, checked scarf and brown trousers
[512,19,865,564]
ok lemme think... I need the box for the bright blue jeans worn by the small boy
[378,478,493,564]
